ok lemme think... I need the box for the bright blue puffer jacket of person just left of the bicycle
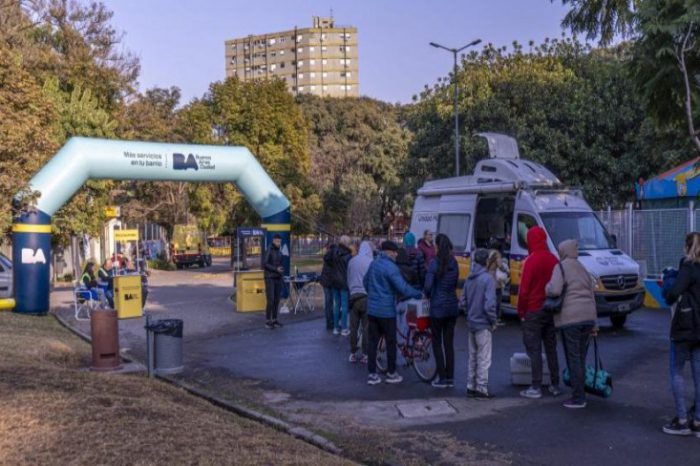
[363,253,422,318]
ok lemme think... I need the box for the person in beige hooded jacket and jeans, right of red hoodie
[546,239,597,409]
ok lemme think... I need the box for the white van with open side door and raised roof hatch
[411,133,645,327]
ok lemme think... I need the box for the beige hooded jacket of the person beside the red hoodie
[546,239,597,327]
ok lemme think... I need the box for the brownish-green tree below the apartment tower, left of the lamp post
[298,95,410,233]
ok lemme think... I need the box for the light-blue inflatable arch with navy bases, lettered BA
[12,137,290,314]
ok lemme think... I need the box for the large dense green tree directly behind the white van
[407,39,687,207]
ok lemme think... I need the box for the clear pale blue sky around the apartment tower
[105,0,576,103]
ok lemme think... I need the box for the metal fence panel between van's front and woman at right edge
[632,209,690,275]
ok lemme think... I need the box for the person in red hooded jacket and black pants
[518,227,561,398]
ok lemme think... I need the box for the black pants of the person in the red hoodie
[522,311,559,388]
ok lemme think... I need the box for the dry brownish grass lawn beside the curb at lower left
[0,312,351,465]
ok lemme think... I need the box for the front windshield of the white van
[540,212,615,251]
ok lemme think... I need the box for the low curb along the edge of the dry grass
[50,312,348,459]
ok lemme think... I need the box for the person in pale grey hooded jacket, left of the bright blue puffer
[348,241,374,364]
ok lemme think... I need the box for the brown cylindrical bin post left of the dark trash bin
[90,309,121,372]
